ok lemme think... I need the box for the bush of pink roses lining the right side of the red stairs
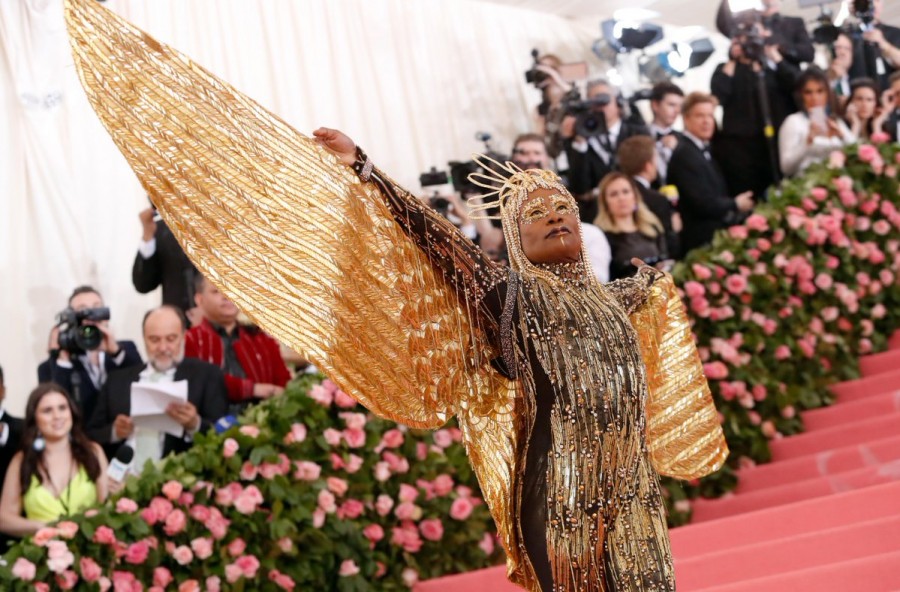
[666,138,900,523]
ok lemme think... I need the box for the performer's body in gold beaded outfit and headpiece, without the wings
[313,128,675,592]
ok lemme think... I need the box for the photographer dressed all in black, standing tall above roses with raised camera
[710,22,800,200]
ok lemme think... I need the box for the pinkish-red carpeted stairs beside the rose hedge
[416,339,900,592]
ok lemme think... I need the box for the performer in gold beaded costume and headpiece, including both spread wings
[66,0,727,592]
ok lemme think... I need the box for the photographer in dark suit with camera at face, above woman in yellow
[38,286,143,417]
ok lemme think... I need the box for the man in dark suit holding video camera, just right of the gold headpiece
[561,80,650,222]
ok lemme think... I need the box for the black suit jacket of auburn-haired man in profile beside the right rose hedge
[668,138,740,255]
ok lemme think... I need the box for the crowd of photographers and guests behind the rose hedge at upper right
[450,0,900,282]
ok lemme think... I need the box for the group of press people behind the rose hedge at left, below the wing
[0,215,299,552]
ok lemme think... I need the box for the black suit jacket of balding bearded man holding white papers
[87,358,228,458]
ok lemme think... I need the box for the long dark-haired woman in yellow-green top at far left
[0,383,107,536]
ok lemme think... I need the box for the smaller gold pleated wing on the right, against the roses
[631,276,728,479]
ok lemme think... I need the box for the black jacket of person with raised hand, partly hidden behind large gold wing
[131,222,197,310]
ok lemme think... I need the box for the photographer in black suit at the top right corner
[850,0,900,88]
